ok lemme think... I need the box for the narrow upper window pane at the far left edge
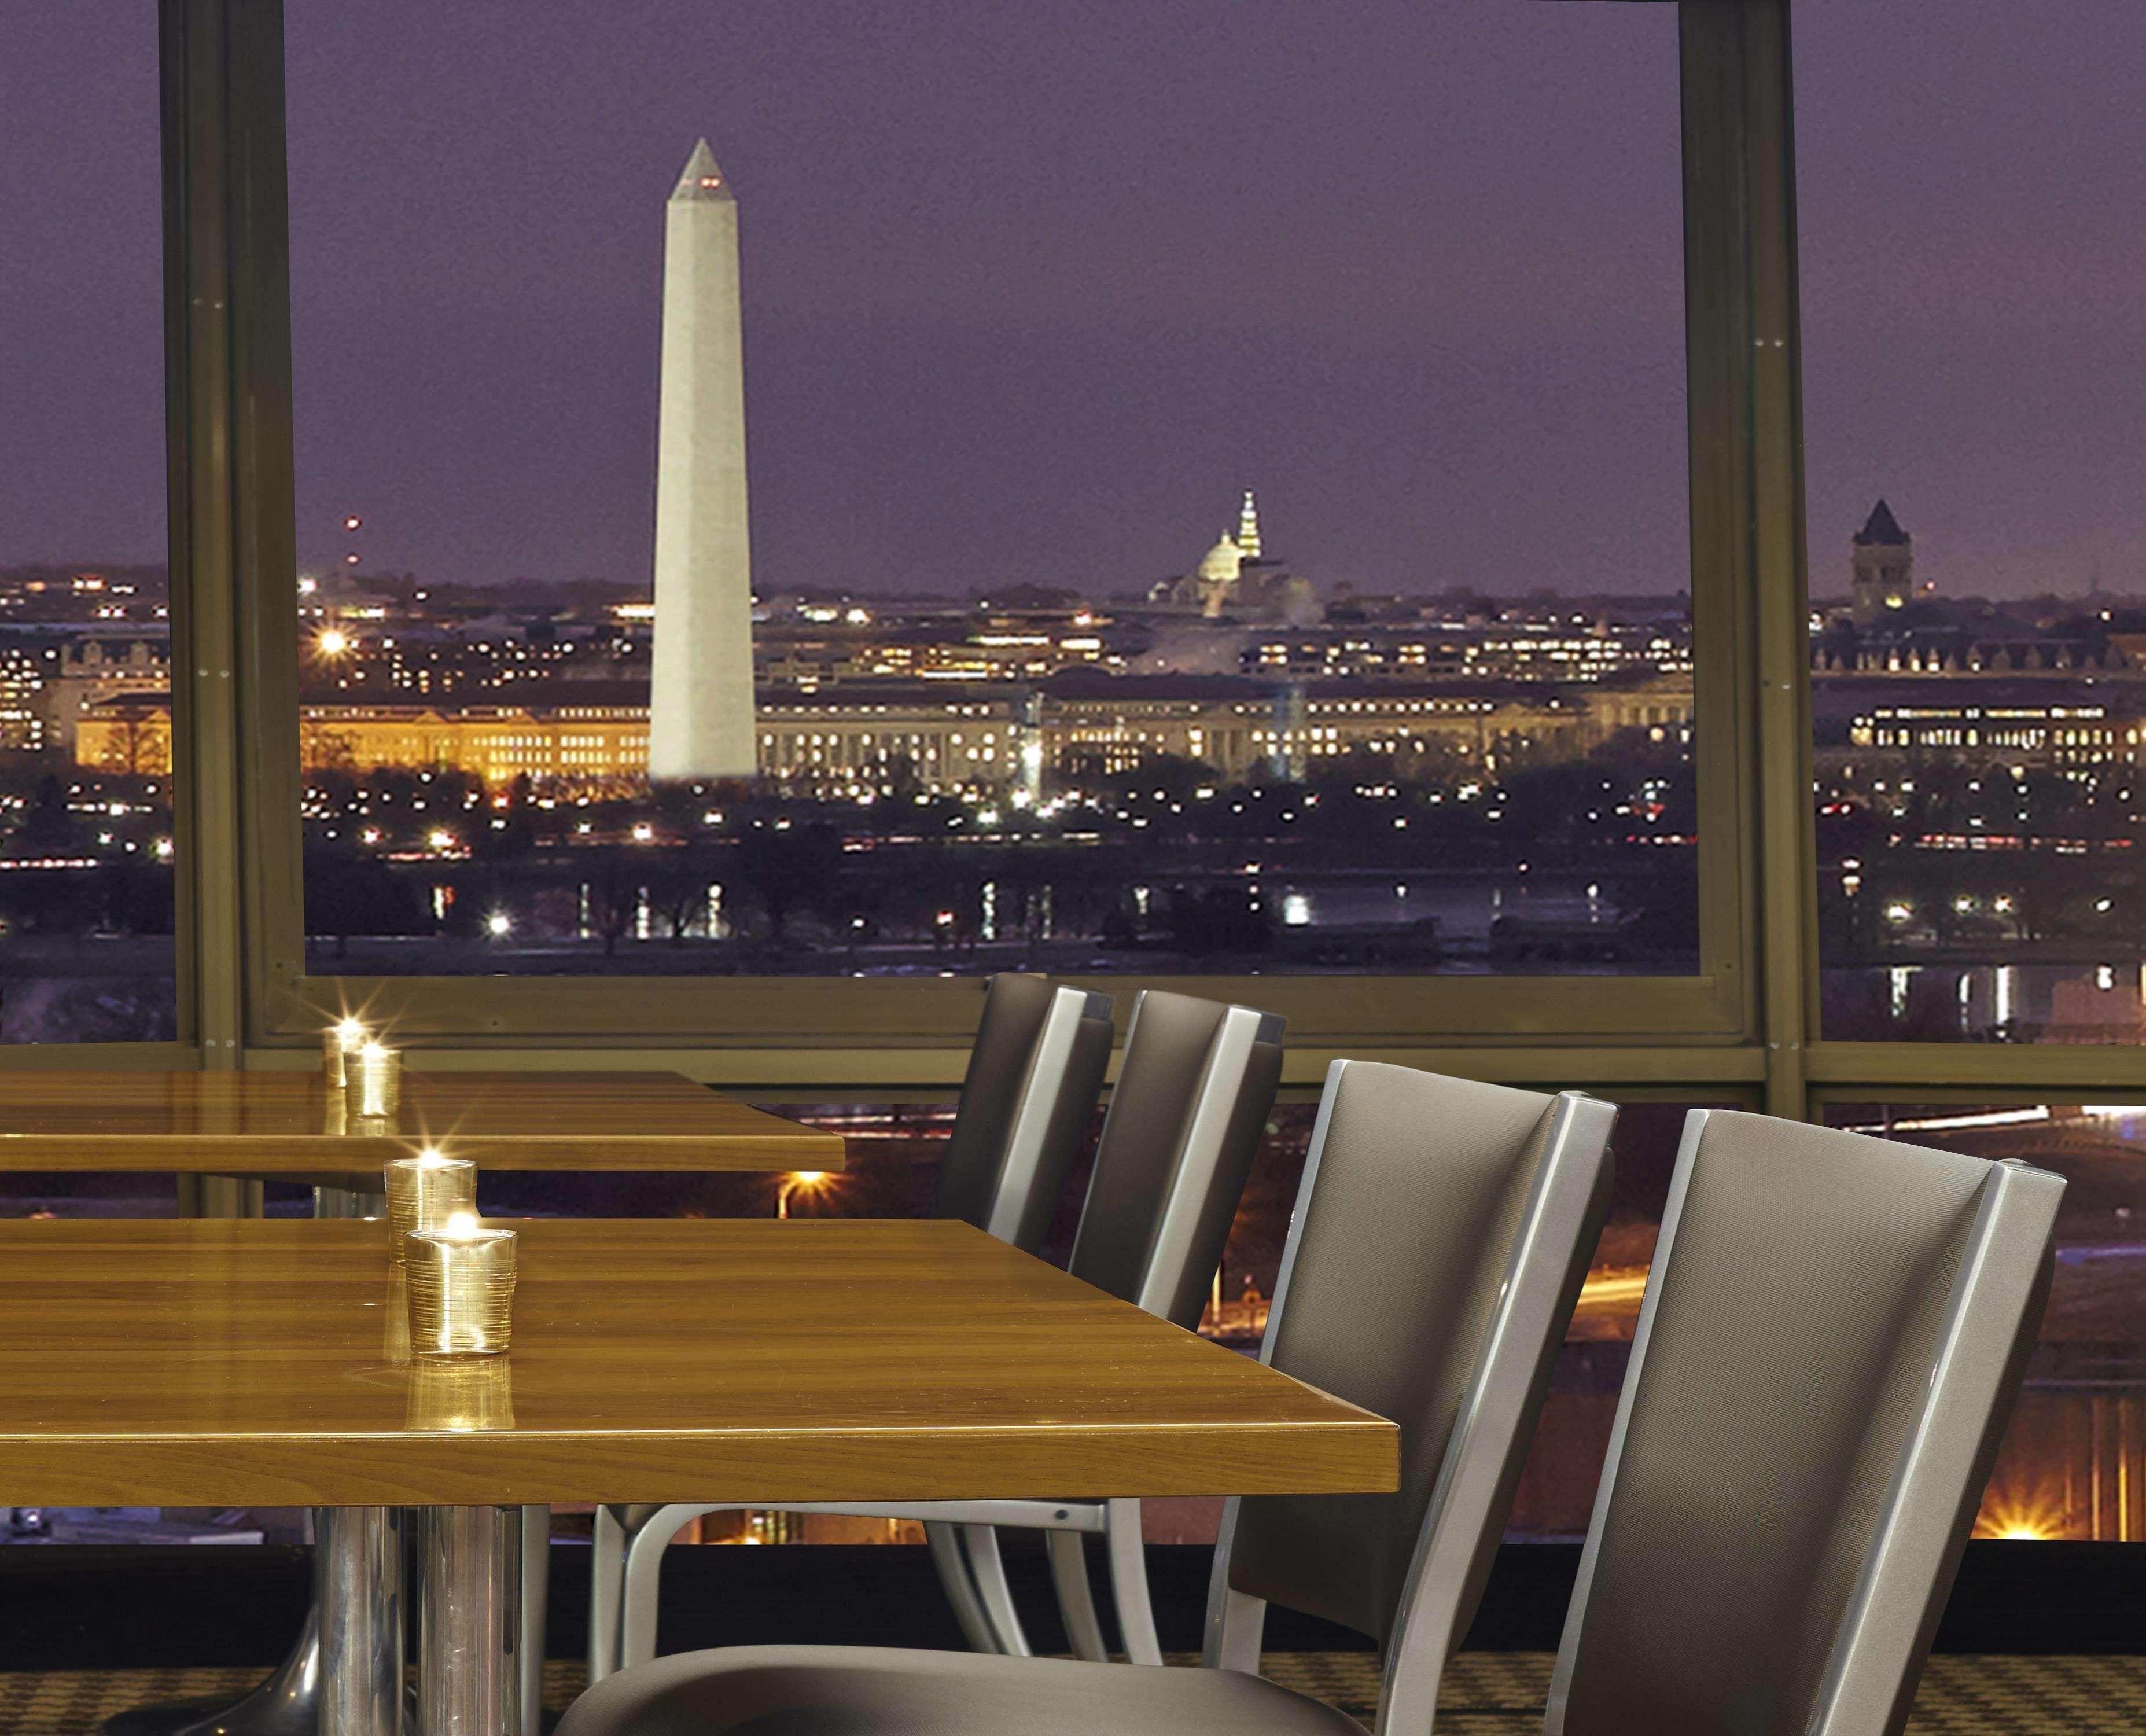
[0,0,176,1043]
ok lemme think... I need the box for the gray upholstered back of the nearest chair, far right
[1549,1109,2064,1736]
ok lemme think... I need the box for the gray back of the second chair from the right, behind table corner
[1210,1062,1616,1682]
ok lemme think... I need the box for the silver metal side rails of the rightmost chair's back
[1543,1109,2064,1736]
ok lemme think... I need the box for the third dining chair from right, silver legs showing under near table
[590,990,1283,1680]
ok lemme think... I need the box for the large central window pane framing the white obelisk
[288,0,1698,974]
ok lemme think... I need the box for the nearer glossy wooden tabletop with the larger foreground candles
[0,1219,1397,1506]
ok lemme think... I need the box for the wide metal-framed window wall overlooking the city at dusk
[0,0,2146,1539]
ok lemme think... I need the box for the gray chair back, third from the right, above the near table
[1066,990,1281,1330]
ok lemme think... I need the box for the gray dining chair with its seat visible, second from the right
[558,1060,1616,1736]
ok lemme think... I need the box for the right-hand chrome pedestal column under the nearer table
[418,1506,526,1736]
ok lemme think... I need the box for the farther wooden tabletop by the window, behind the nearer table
[0,1069,841,1176]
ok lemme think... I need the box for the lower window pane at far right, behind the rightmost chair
[1826,1103,2146,1543]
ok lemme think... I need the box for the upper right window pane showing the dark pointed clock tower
[1796,0,2146,1043]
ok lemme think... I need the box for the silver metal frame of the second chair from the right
[1199,1060,1616,1736]
